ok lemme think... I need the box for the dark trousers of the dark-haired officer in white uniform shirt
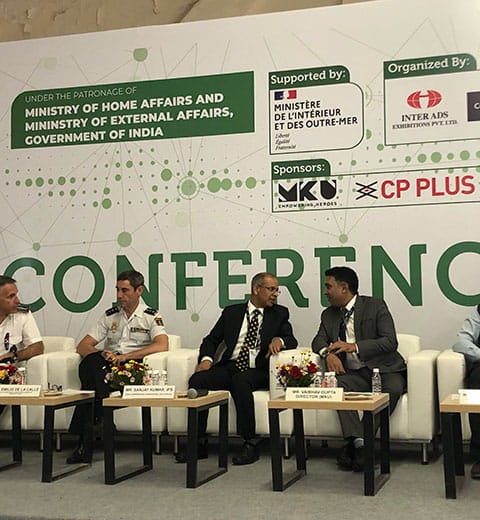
[68,352,112,435]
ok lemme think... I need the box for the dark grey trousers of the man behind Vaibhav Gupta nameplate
[337,367,407,439]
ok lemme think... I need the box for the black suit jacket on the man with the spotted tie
[198,303,297,370]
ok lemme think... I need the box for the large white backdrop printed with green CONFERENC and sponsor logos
[0,0,480,348]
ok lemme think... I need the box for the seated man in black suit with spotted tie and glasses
[176,273,297,465]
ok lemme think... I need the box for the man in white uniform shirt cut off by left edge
[0,276,44,413]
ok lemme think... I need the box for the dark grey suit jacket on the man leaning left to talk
[312,296,407,372]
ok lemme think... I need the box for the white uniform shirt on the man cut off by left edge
[0,309,42,354]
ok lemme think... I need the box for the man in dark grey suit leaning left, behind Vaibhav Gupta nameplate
[312,267,407,471]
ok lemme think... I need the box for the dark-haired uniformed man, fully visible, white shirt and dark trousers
[67,271,168,464]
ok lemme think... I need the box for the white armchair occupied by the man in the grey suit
[304,334,439,464]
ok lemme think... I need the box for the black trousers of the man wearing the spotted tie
[188,361,268,440]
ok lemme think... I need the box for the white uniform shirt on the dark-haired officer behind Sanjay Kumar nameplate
[88,302,166,354]
